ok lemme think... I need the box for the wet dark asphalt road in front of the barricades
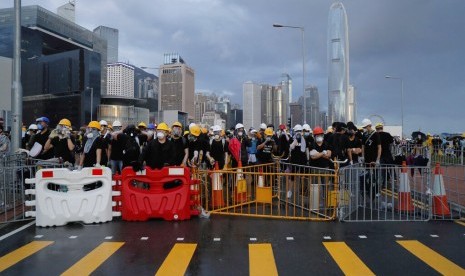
[0,215,465,275]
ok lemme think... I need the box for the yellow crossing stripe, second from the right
[323,242,375,275]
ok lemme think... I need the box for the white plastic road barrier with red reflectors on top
[25,168,121,227]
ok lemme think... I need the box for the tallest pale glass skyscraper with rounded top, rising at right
[328,2,349,124]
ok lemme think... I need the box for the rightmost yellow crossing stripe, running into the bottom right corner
[397,240,465,275]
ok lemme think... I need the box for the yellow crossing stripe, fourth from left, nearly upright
[249,243,278,276]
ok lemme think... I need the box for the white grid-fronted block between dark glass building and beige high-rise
[107,62,134,98]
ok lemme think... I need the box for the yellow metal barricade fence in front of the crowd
[194,162,339,221]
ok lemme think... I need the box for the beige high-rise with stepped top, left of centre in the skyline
[158,54,195,120]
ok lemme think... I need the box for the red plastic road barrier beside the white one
[115,167,196,221]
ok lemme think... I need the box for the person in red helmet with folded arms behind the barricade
[310,126,331,169]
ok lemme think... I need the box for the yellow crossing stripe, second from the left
[61,242,124,275]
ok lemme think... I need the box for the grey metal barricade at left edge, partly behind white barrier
[0,154,63,224]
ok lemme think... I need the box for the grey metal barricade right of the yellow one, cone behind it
[338,164,431,222]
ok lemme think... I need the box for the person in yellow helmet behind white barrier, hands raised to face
[45,119,76,164]
